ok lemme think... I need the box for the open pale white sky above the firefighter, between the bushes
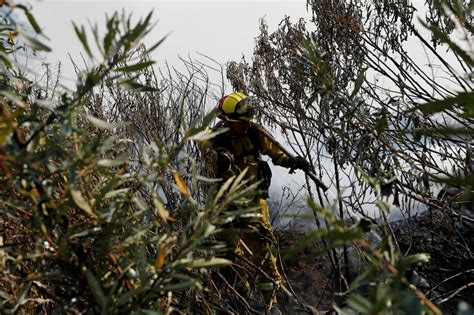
[30,0,308,83]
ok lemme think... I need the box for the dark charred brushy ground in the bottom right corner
[392,209,474,314]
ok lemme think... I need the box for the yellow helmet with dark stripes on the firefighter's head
[217,92,256,122]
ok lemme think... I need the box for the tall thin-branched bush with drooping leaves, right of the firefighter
[227,1,474,314]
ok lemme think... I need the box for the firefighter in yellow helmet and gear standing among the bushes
[200,92,310,308]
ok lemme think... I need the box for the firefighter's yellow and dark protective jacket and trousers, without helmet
[199,121,286,299]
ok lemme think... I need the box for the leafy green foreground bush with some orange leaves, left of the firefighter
[0,3,260,314]
